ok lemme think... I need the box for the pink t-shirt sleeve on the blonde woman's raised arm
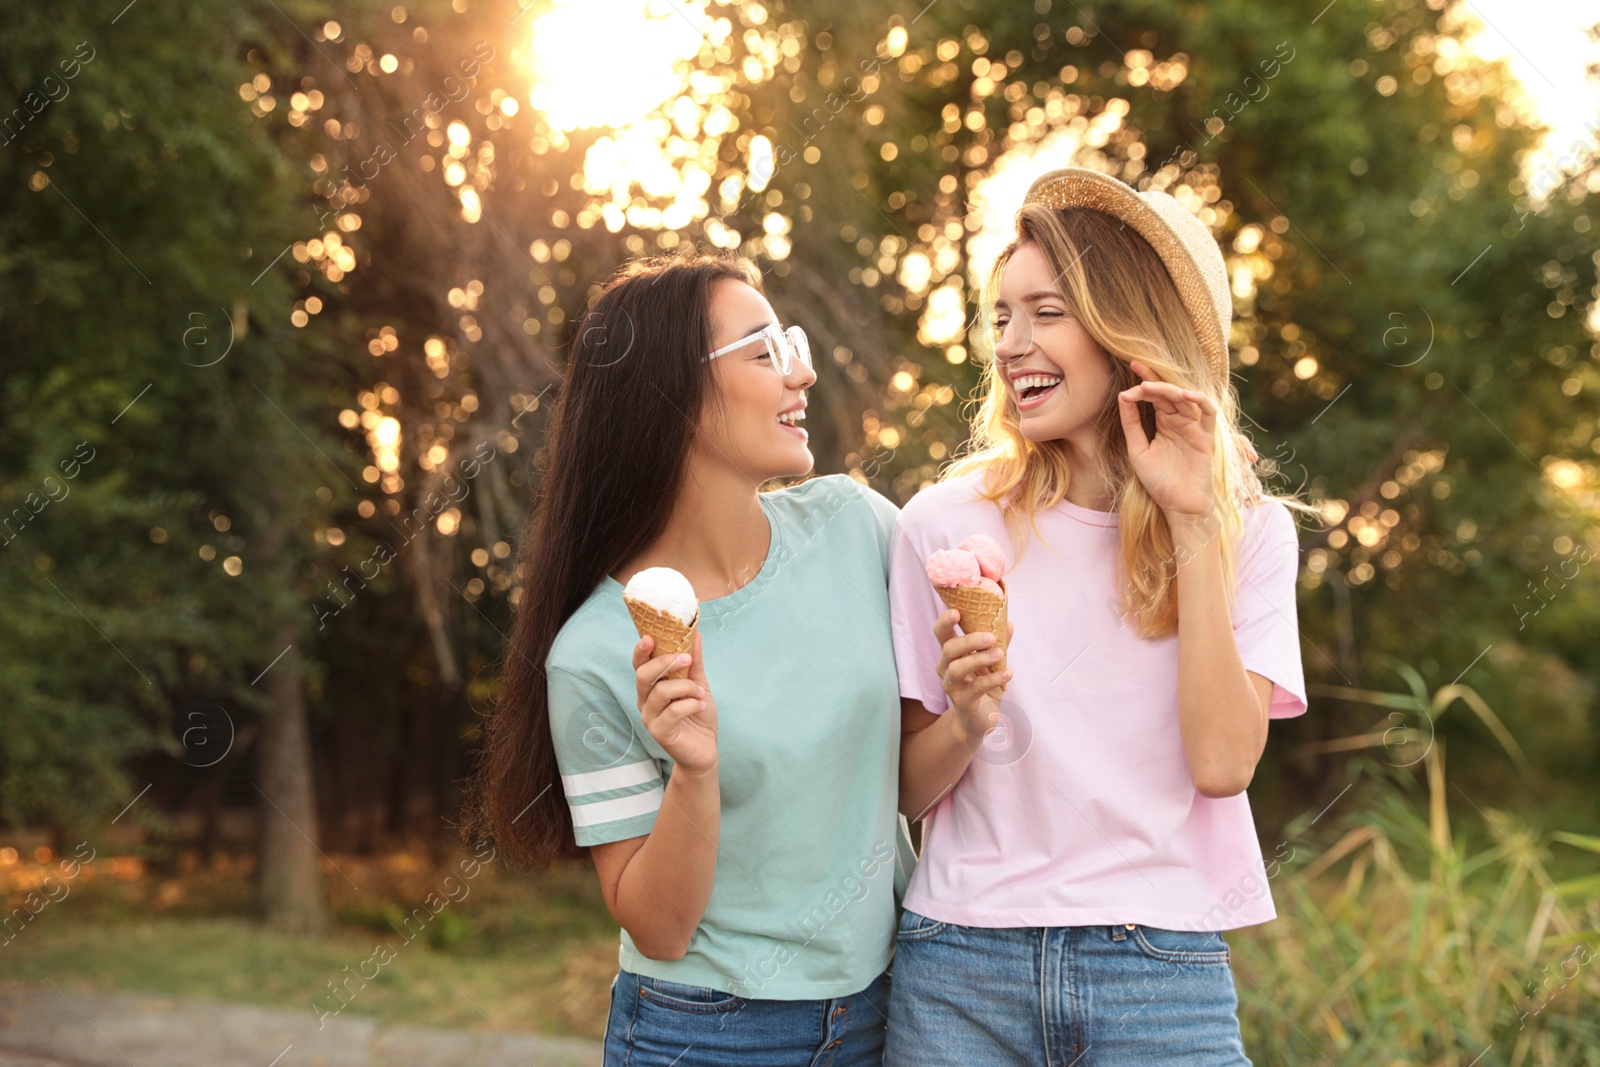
[1234,501,1306,718]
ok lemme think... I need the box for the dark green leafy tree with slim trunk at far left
[0,2,352,929]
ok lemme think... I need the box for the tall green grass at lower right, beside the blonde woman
[1230,741,1600,1067]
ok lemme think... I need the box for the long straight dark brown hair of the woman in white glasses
[462,256,760,869]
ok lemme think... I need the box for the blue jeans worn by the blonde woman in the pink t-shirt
[883,910,1250,1067]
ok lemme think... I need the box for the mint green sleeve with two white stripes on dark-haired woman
[546,665,666,845]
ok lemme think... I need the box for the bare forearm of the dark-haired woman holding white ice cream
[614,766,722,960]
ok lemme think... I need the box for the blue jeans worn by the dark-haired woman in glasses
[605,971,890,1067]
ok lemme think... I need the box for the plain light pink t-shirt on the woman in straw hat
[890,474,1306,929]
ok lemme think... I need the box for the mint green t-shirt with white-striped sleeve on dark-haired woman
[546,475,915,1000]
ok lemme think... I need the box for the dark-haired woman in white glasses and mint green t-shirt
[469,258,910,1067]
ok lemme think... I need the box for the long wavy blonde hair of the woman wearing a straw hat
[939,203,1278,638]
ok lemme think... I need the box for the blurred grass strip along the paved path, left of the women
[0,854,618,1037]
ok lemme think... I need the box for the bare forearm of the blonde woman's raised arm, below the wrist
[1171,520,1267,797]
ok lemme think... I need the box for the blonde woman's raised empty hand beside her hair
[1117,360,1216,520]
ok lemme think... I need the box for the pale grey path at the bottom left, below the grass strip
[0,984,600,1067]
